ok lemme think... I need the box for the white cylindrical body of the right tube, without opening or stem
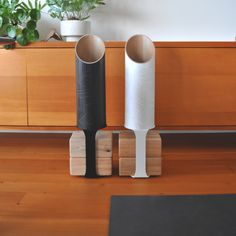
[124,36,155,130]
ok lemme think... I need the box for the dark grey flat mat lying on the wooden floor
[109,195,236,236]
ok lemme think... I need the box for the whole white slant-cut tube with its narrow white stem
[125,35,155,178]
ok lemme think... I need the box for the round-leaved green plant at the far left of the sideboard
[0,0,45,46]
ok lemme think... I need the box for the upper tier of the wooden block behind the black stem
[70,131,112,158]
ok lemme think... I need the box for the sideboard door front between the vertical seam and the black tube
[27,48,76,126]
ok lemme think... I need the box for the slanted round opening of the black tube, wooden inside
[75,35,105,64]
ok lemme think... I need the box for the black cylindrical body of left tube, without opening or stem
[76,55,106,130]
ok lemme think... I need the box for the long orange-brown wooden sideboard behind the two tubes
[0,42,236,130]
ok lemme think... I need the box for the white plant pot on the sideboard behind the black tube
[60,20,91,42]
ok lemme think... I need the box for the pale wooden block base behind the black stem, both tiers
[70,130,112,176]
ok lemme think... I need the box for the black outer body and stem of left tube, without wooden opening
[76,50,106,178]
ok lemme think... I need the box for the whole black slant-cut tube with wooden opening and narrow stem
[76,35,106,178]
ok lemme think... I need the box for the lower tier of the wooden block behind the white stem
[119,157,162,176]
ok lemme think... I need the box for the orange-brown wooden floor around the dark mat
[0,134,236,236]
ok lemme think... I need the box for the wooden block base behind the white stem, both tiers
[119,130,162,176]
